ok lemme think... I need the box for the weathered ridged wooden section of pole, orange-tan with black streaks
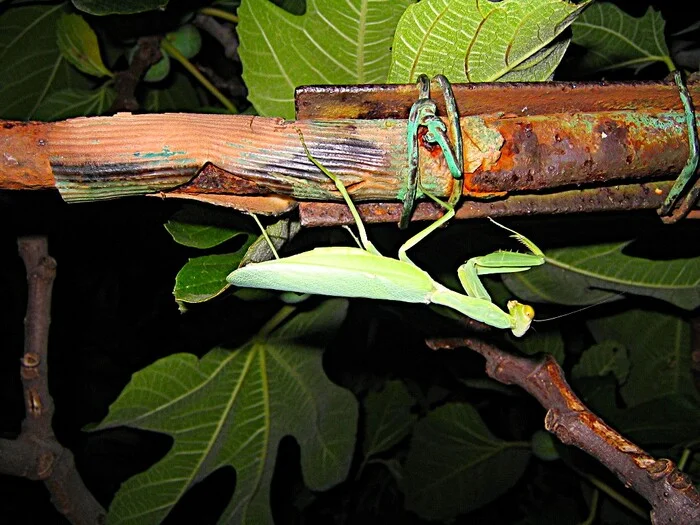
[49,114,404,201]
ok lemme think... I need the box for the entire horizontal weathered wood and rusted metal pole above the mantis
[0,82,700,224]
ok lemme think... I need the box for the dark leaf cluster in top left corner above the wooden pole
[0,0,202,121]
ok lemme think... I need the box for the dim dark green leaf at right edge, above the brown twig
[588,310,695,407]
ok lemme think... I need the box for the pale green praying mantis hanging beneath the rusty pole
[226,132,545,337]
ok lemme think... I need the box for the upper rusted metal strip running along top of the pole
[295,80,700,120]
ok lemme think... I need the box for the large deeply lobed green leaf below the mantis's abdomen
[97,299,357,525]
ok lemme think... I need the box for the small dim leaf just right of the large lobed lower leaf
[362,381,416,458]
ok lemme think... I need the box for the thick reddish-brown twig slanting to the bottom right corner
[427,338,700,524]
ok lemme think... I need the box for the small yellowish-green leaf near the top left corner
[56,15,114,77]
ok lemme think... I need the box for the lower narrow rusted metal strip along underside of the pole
[299,182,673,227]
